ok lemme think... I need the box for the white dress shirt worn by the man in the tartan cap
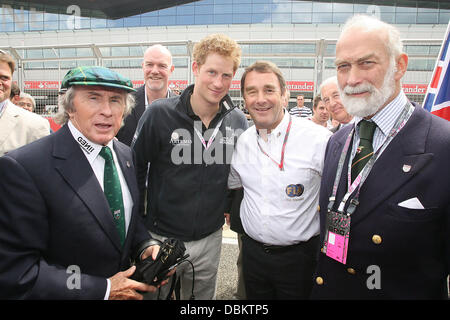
[68,120,133,300]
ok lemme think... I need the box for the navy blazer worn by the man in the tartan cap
[0,125,149,299]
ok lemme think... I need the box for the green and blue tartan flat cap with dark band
[61,66,136,92]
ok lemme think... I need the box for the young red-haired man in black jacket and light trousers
[132,34,248,300]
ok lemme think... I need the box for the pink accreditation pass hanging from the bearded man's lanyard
[324,211,350,264]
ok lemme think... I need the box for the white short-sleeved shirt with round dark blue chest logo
[228,112,331,246]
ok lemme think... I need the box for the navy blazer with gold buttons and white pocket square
[311,107,450,299]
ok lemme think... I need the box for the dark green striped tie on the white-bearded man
[352,120,377,182]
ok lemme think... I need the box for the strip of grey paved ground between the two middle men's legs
[216,225,238,300]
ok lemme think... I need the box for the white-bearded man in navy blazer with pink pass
[311,16,450,299]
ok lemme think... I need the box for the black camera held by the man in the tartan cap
[131,238,189,286]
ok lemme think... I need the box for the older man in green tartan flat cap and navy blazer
[0,67,168,299]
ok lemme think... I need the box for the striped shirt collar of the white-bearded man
[354,90,408,136]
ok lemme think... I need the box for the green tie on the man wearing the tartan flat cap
[100,147,125,245]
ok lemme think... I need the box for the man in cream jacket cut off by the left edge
[0,50,50,156]
